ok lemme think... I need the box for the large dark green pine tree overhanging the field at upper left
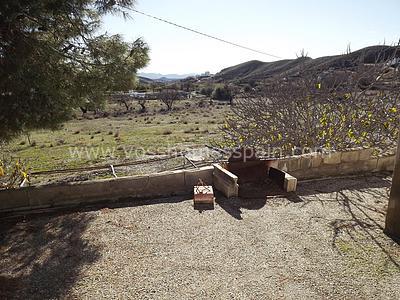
[0,0,149,141]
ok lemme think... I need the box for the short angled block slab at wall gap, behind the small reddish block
[213,164,239,198]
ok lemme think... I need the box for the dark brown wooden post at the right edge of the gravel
[385,135,400,240]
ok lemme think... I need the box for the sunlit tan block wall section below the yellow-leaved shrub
[274,148,396,179]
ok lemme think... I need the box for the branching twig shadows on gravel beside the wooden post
[297,174,400,271]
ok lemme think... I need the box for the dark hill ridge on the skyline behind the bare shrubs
[213,46,400,83]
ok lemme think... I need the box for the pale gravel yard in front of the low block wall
[0,175,400,299]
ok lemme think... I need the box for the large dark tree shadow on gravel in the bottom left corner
[0,213,100,299]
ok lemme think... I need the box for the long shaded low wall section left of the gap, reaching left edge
[0,166,214,212]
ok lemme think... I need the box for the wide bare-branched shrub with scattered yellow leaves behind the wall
[223,46,400,155]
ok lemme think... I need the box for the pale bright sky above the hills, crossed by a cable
[104,0,400,74]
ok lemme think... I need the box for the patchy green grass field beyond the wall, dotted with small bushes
[4,99,230,182]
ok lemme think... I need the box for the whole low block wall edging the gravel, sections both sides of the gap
[0,149,396,213]
